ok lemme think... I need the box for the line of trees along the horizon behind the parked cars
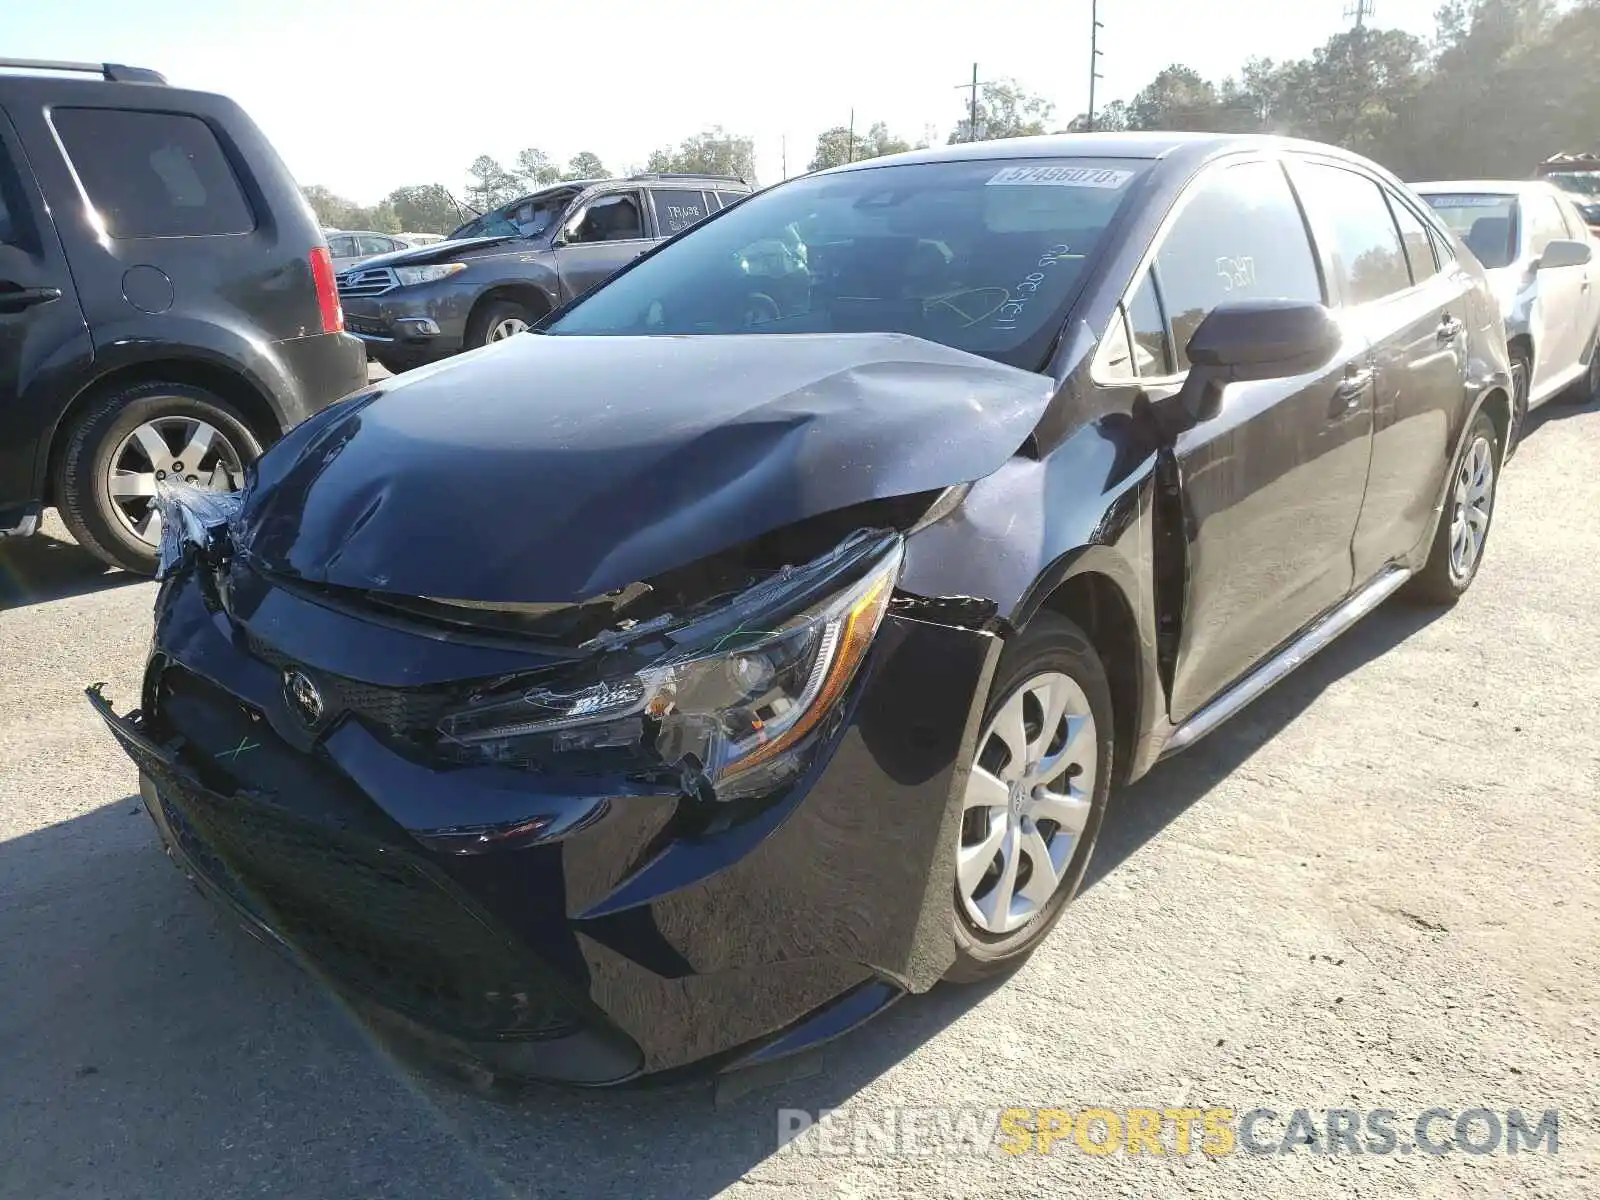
[306,0,1600,234]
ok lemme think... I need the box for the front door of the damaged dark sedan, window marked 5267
[1128,158,1371,723]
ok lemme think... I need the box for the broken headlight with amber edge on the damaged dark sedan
[440,538,902,800]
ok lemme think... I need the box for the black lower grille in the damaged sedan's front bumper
[142,763,581,1040]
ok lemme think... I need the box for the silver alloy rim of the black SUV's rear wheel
[106,416,245,546]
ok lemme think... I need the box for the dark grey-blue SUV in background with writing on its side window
[339,174,750,371]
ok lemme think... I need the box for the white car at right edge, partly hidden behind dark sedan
[1413,179,1600,440]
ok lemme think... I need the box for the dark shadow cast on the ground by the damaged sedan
[0,605,1437,1200]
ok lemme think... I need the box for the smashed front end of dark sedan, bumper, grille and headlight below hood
[106,488,997,1082]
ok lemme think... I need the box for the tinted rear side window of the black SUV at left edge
[51,109,256,237]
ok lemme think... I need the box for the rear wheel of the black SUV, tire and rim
[54,382,261,574]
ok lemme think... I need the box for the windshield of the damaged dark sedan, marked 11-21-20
[547,158,1147,370]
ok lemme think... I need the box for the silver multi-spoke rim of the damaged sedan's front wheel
[955,670,1099,936]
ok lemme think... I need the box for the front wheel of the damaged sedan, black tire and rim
[946,613,1114,982]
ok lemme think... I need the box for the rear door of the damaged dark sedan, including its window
[1291,160,1472,584]
